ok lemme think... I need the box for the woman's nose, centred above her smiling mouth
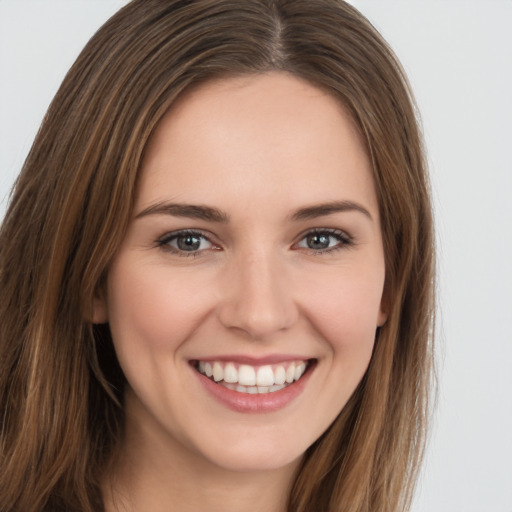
[218,249,298,340]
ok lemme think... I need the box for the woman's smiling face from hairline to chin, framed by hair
[95,73,385,470]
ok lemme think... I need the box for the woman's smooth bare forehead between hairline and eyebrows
[139,72,375,215]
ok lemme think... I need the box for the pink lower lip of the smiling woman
[194,364,314,413]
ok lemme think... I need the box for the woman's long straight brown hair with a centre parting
[0,0,434,512]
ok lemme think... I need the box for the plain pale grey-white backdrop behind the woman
[0,0,512,512]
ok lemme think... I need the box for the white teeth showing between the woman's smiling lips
[192,359,315,394]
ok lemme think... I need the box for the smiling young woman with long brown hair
[0,0,433,512]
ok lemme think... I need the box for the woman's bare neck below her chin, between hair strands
[104,394,300,512]
